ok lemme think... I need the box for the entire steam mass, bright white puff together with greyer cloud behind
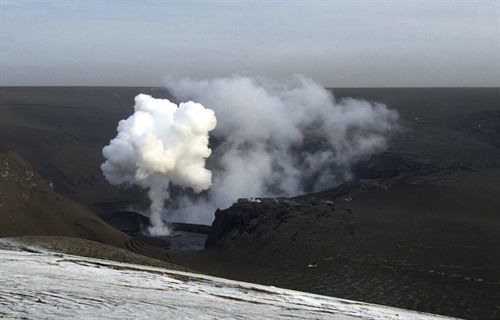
[102,76,398,230]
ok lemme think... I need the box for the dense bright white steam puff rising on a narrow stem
[101,94,216,235]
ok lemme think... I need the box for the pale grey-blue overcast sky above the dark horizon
[0,0,500,87]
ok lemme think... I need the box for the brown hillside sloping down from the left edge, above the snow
[0,151,129,247]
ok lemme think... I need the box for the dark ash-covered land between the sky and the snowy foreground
[0,87,500,319]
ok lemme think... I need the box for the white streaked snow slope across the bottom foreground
[0,246,458,319]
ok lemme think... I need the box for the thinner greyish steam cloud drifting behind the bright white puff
[166,75,398,223]
